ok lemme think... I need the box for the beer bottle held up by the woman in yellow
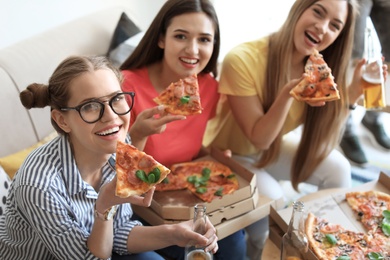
[362,28,386,109]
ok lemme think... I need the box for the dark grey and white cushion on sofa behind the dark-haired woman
[107,13,142,66]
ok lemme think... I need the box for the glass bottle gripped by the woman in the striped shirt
[185,204,213,260]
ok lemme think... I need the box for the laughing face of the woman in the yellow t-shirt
[294,0,348,56]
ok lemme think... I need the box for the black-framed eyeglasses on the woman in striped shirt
[61,92,135,124]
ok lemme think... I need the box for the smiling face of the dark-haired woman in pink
[158,13,215,78]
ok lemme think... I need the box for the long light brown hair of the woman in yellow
[258,0,358,190]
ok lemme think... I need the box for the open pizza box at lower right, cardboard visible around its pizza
[269,172,390,260]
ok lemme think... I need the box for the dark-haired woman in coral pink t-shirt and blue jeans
[120,0,246,259]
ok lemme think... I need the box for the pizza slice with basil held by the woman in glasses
[115,141,170,198]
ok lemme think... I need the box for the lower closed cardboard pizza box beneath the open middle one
[132,192,283,239]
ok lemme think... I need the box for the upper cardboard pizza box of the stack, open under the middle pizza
[145,149,258,220]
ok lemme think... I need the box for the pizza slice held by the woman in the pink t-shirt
[153,74,203,116]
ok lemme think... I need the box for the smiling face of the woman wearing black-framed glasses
[59,69,130,156]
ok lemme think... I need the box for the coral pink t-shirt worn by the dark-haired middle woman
[123,68,219,167]
